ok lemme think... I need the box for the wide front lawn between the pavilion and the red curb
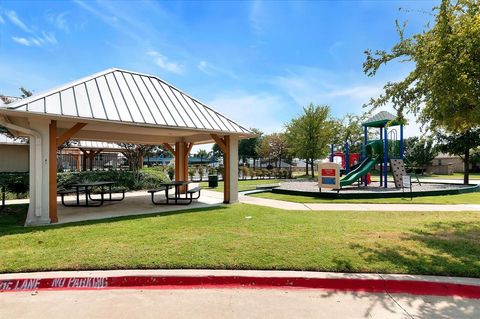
[0,204,480,277]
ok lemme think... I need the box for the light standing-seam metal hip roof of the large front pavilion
[2,69,251,134]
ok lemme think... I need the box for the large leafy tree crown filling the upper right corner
[363,0,480,133]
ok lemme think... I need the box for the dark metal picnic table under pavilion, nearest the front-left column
[58,181,125,207]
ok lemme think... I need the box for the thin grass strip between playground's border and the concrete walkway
[249,192,480,204]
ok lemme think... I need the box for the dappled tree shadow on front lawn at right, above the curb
[350,222,480,278]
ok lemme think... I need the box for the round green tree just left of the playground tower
[286,104,334,177]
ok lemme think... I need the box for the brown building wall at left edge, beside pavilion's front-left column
[0,144,29,172]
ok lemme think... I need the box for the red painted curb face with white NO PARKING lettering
[0,276,480,299]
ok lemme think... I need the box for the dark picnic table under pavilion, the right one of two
[148,181,201,205]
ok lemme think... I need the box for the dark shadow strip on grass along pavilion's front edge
[0,204,227,237]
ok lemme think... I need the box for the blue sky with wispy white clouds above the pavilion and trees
[0,1,438,142]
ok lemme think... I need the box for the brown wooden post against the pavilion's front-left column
[48,120,58,223]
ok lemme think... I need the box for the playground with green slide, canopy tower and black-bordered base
[271,111,479,199]
